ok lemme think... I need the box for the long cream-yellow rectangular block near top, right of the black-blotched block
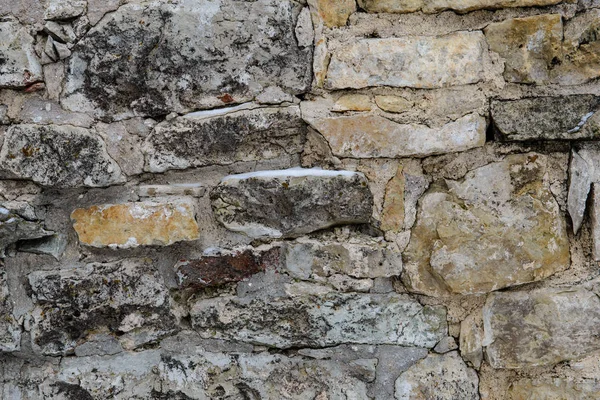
[325,32,486,89]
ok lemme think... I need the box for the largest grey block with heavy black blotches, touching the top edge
[63,0,312,119]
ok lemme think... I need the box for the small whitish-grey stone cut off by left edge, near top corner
[0,19,43,89]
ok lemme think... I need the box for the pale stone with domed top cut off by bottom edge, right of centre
[395,351,479,400]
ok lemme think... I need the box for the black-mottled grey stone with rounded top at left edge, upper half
[0,125,122,187]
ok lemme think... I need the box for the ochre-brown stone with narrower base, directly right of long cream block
[484,14,563,84]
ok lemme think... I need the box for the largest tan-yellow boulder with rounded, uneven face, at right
[403,153,570,296]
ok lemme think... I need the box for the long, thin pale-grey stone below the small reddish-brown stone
[190,292,447,348]
